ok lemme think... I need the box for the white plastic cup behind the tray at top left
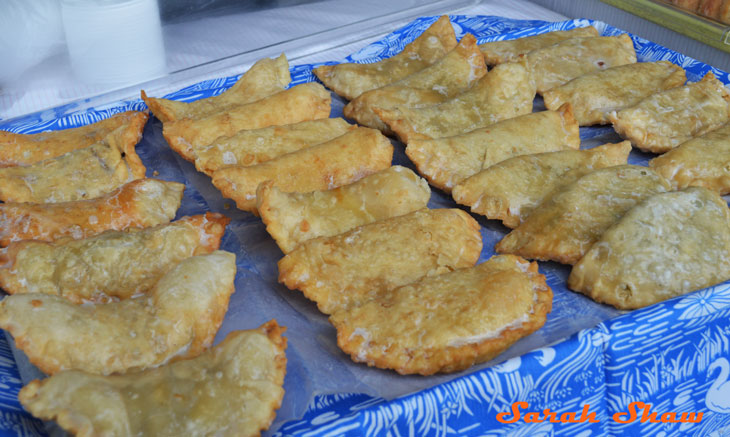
[61,0,166,85]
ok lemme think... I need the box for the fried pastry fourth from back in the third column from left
[406,105,580,193]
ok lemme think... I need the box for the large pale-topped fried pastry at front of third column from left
[568,187,730,309]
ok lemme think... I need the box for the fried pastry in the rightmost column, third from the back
[542,61,687,126]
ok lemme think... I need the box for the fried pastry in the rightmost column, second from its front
[609,72,730,153]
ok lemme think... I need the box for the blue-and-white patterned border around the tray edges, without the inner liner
[0,16,730,437]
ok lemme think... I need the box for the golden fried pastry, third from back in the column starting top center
[373,63,535,144]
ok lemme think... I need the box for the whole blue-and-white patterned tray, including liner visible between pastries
[0,16,730,437]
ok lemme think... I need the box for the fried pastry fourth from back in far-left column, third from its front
[0,213,230,303]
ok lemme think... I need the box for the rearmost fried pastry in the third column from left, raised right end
[314,15,456,100]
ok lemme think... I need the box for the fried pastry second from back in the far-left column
[0,127,146,203]
